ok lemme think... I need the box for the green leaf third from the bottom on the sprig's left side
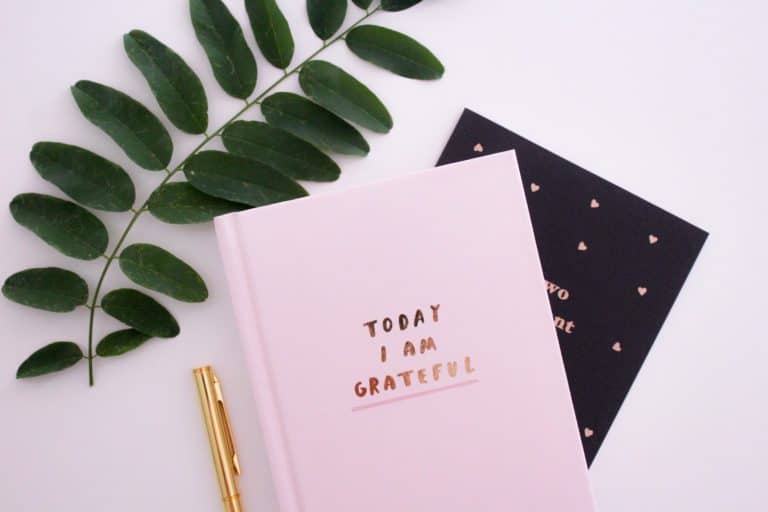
[11,194,109,260]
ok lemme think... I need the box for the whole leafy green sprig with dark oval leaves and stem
[7,0,444,385]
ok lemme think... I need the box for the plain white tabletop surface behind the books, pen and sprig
[0,0,768,512]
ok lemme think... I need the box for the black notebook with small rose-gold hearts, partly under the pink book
[438,110,707,464]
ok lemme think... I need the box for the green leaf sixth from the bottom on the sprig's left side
[123,30,208,134]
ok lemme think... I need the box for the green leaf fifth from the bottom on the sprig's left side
[72,80,173,171]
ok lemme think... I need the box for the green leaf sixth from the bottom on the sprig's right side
[224,121,341,182]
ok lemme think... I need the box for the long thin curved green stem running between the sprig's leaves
[85,6,381,386]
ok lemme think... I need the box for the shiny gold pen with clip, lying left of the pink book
[193,366,243,512]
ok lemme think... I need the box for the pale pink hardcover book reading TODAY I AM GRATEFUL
[216,152,593,512]
